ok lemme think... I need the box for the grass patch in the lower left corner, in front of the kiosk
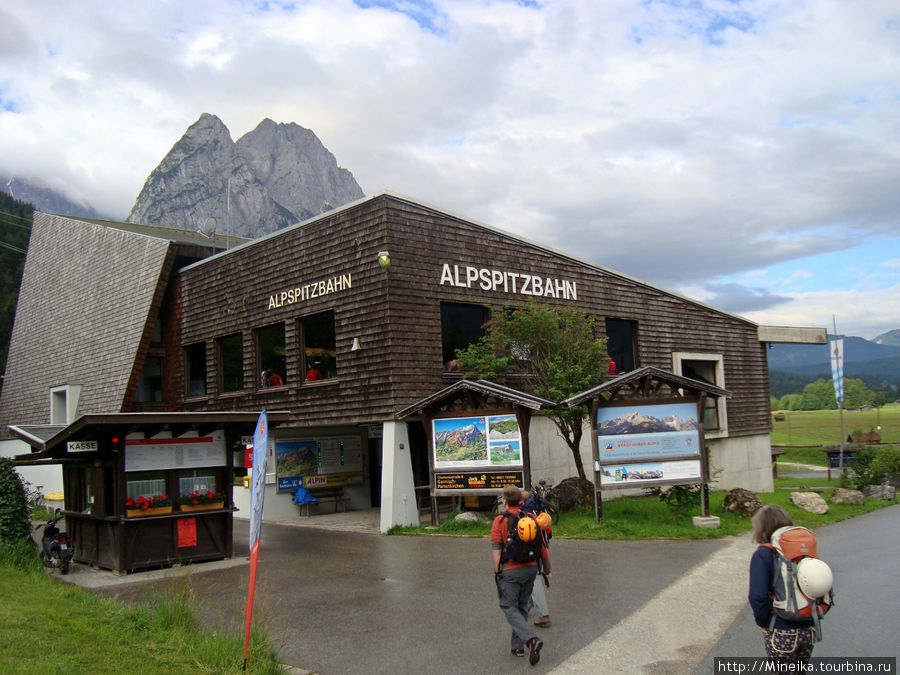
[0,544,279,673]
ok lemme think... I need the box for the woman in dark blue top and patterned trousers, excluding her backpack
[748,504,815,664]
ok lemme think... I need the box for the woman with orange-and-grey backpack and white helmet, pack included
[748,504,833,664]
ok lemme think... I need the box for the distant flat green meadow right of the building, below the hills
[772,403,900,447]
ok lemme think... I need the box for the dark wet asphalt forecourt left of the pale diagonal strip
[81,512,726,673]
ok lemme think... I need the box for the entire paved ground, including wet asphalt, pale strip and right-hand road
[61,505,900,674]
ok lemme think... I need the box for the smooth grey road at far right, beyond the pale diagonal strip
[696,505,900,673]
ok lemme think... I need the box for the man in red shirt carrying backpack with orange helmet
[491,485,550,666]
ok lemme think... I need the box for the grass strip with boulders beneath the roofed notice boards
[388,484,896,540]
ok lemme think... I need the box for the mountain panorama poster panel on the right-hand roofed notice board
[595,401,703,488]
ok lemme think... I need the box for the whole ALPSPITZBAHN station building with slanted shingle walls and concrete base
[0,193,824,552]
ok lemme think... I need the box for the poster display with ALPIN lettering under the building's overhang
[275,436,362,492]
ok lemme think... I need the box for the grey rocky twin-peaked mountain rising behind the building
[128,113,364,238]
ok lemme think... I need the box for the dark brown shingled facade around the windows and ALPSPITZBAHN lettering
[179,194,770,436]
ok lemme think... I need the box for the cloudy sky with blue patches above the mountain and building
[0,0,900,339]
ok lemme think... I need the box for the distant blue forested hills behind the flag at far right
[768,330,900,397]
